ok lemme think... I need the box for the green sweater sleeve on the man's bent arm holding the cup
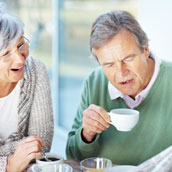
[66,80,99,160]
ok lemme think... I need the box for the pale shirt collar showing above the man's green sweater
[108,58,161,108]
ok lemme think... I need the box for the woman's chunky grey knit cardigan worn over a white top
[0,57,53,172]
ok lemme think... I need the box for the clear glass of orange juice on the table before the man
[80,157,112,172]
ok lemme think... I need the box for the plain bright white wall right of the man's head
[138,0,172,61]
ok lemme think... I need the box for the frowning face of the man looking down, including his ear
[95,30,150,98]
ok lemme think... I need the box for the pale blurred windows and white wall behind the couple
[1,0,172,157]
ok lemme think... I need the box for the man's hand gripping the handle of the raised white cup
[82,104,110,142]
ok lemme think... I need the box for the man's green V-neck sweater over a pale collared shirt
[66,62,172,165]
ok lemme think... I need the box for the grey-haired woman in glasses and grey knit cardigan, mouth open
[0,4,53,172]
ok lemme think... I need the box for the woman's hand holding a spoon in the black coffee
[6,136,45,172]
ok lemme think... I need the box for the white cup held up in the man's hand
[108,109,139,131]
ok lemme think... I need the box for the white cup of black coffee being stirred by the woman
[36,153,63,172]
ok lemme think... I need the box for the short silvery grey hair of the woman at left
[0,2,24,51]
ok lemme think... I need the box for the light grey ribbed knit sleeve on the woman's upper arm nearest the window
[28,60,54,152]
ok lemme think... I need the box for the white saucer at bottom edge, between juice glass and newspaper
[105,165,136,172]
